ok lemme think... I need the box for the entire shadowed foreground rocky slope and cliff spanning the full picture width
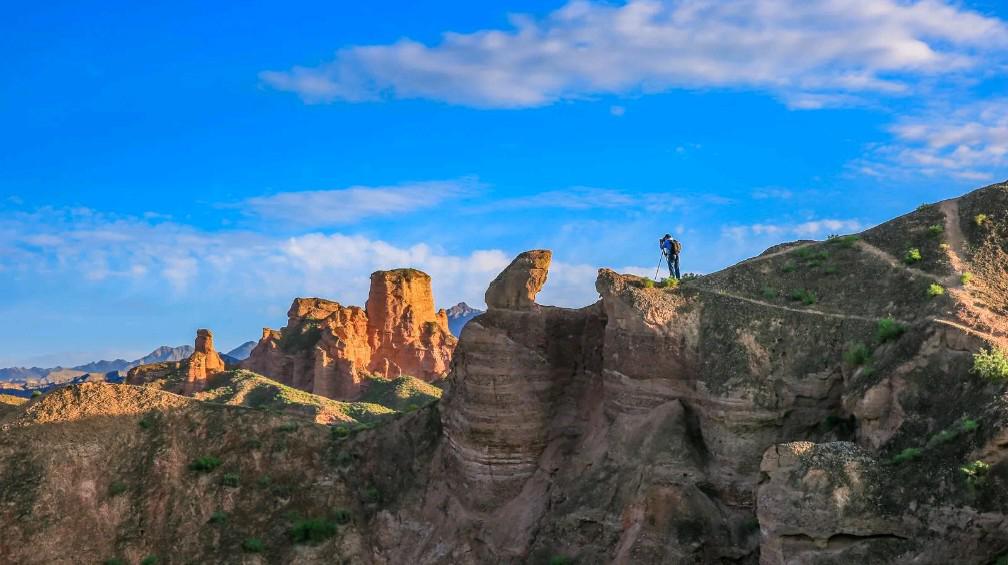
[0,184,1008,565]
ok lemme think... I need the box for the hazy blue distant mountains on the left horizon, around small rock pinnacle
[0,341,255,384]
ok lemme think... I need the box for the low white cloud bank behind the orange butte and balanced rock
[0,204,596,308]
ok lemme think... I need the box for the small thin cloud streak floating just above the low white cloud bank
[242,178,481,228]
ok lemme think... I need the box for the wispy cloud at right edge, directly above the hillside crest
[854,99,1008,180]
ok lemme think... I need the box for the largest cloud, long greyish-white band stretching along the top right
[260,0,1008,108]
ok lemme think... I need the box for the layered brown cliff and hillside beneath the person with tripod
[382,185,1008,564]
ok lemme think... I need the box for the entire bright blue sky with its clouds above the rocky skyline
[0,0,1008,367]
